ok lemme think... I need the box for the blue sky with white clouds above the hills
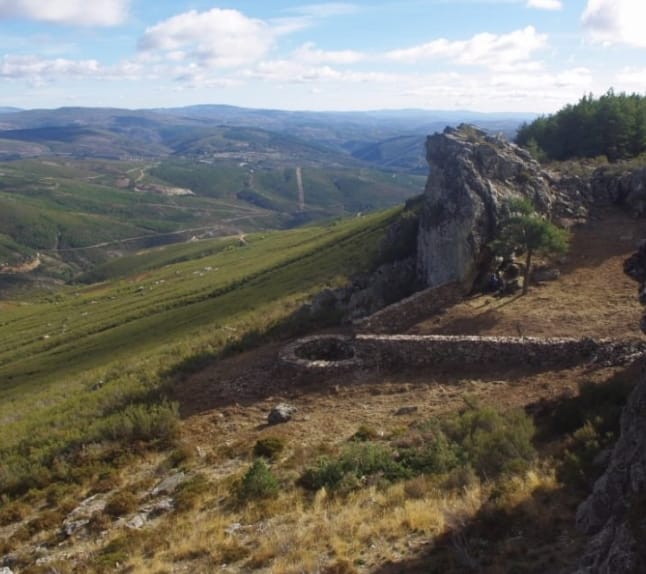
[0,0,646,113]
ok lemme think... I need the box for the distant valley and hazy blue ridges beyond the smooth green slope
[0,105,531,284]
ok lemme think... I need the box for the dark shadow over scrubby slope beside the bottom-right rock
[374,360,644,574]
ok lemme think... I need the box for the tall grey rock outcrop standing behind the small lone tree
[417,126,557,287]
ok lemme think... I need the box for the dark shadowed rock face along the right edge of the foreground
[576,242,646,574]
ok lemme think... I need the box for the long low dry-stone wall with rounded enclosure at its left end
[280,334,646,372]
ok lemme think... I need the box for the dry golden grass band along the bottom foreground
[119,469,557,574]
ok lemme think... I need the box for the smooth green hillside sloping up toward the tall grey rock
[0,209,400,498]
